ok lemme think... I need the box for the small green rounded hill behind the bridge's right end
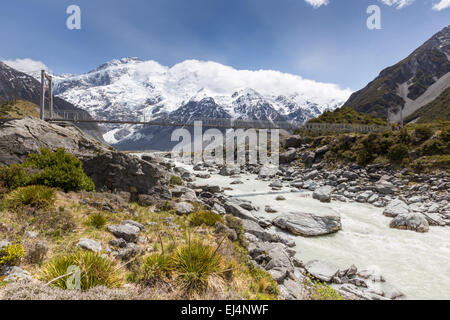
[309,107,386,125]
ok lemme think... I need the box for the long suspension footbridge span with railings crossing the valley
[45,110,388,133]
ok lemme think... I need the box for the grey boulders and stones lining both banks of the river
[148,155,448,299]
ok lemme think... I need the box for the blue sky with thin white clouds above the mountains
[0,0,450,90]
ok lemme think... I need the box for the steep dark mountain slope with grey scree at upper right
[344,26,450,120]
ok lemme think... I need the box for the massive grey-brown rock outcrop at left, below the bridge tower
[0,117,170,196]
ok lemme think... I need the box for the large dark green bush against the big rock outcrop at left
[24,149,95,192]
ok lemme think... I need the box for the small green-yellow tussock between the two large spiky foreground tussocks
[142,253,173,285]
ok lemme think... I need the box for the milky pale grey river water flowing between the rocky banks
[168,163,450,299]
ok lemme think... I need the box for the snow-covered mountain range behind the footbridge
[51,58,351,150]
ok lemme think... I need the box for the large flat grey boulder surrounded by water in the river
[272,212,342,237]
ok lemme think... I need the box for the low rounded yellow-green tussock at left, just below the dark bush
[5,186,56,209]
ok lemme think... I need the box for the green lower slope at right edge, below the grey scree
[406,87,450,123]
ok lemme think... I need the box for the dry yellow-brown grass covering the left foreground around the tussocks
[0,191,278,300]
